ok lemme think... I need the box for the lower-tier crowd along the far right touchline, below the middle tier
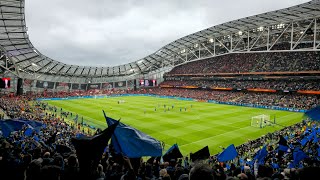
[149,88,320,109]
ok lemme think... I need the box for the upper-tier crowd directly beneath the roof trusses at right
[168,51,320,74]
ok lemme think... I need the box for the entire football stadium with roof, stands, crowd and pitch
[0,0,320,180]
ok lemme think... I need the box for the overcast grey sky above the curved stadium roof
[25,0,309,66]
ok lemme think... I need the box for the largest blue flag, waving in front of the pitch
[103,111,162,158]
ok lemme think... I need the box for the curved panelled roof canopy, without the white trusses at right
[0,0,320,78]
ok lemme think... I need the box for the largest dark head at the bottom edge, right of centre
[189,164,214,180]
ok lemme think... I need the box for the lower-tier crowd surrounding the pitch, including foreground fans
[0,88,320,180]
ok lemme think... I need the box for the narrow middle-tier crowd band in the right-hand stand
[161,80,320,91]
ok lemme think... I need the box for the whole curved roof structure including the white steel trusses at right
[0,0,320,81]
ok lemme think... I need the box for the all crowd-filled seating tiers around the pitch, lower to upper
[0,49,320,180]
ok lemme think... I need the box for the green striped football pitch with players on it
[46,96,303,155]
